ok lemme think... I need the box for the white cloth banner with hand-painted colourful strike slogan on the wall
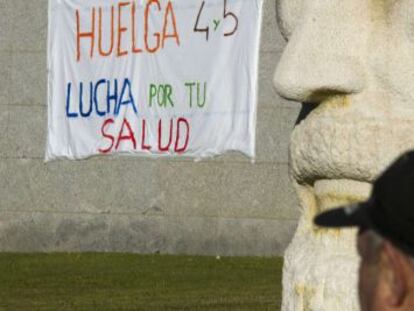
[46,0,263,160]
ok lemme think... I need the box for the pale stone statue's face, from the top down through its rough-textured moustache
[274,0,414,193]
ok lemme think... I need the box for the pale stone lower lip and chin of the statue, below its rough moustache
[282,179,371,311]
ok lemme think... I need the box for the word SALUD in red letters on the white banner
[98,118,190,154]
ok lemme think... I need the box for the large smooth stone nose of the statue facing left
[274,17,365,103]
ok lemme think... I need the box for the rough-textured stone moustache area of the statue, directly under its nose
[290,97,414,185]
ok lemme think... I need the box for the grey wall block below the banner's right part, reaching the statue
[152,162,296,220]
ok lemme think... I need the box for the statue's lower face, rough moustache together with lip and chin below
[282,98,414,311]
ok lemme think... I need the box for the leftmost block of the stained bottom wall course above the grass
[0,211,110,252]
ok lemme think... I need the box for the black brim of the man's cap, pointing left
[314,202,370,228]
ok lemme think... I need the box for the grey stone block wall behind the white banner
[0,0,299,256]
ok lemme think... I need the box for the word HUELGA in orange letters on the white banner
[75,0,180,62]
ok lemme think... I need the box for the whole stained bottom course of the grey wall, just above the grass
[0,212,296,256]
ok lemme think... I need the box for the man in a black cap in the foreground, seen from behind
[314,151,414,311]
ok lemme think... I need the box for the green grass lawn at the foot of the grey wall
[0,253,282,311]
